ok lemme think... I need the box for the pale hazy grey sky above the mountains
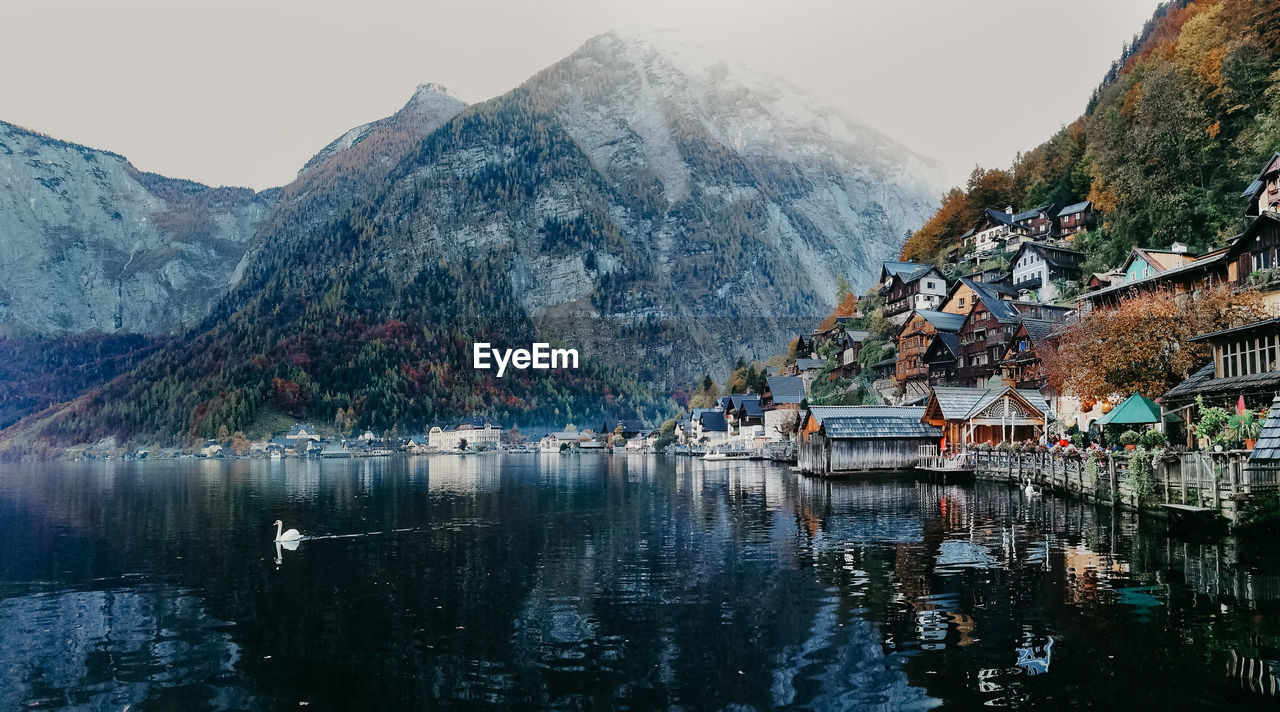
[0,0,1158,188]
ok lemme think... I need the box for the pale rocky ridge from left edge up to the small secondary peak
[0,85,465,334]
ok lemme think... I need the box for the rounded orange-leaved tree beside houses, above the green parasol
[1042,286,1267,400]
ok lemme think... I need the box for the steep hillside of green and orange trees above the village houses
[902,0,1280,274]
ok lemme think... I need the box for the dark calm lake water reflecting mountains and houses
[0,455,1280,709]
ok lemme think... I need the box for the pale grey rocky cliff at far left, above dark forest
[0,122,275,334]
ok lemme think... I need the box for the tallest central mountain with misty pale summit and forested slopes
[0,33,936,450]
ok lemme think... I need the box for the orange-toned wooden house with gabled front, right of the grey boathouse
[922,385,1051,449]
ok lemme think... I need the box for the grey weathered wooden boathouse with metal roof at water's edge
[796,406,942,475]
